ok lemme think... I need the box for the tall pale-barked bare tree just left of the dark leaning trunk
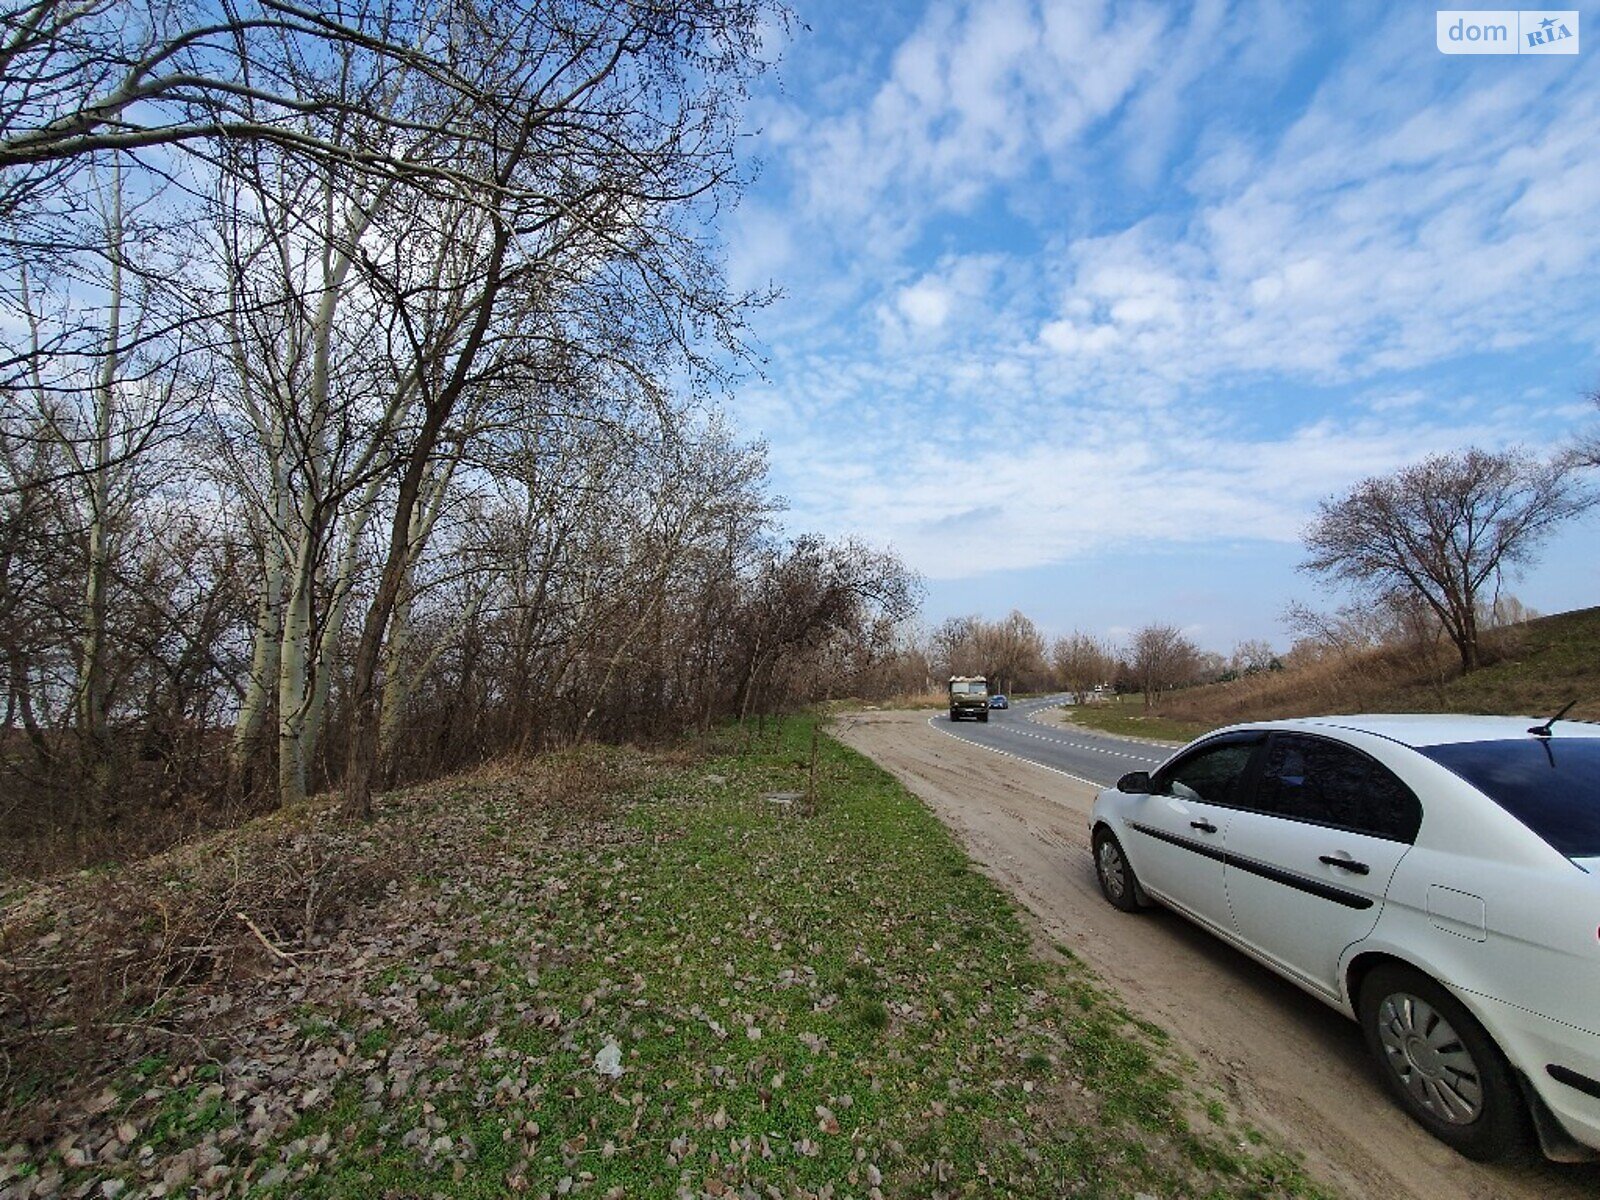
[211,124,416,803]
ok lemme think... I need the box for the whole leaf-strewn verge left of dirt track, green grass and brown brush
[0,720,1323,1200]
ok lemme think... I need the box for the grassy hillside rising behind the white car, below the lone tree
[1067,608,1600,739]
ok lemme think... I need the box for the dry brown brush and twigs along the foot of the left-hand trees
[0,749,638,1146]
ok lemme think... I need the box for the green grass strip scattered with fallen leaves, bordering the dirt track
[43,720,1320,1200]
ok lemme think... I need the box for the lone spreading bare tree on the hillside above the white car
[1301,448,1600,670]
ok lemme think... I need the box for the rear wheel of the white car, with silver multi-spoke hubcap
[1357,963,1531,1162]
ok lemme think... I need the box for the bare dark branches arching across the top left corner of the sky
[0,0,649,227]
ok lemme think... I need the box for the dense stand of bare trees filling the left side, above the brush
[0,0,960,864]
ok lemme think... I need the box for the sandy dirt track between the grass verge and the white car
[835,712,1600,1200]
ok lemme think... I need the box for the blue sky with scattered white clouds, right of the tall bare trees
[725,0,1600,653]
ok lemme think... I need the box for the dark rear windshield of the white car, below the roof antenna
[1418,736,1600,858]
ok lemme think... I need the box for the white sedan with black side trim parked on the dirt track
[1090,715,1600,1162]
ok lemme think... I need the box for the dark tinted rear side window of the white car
[1251,733,1422,843]
